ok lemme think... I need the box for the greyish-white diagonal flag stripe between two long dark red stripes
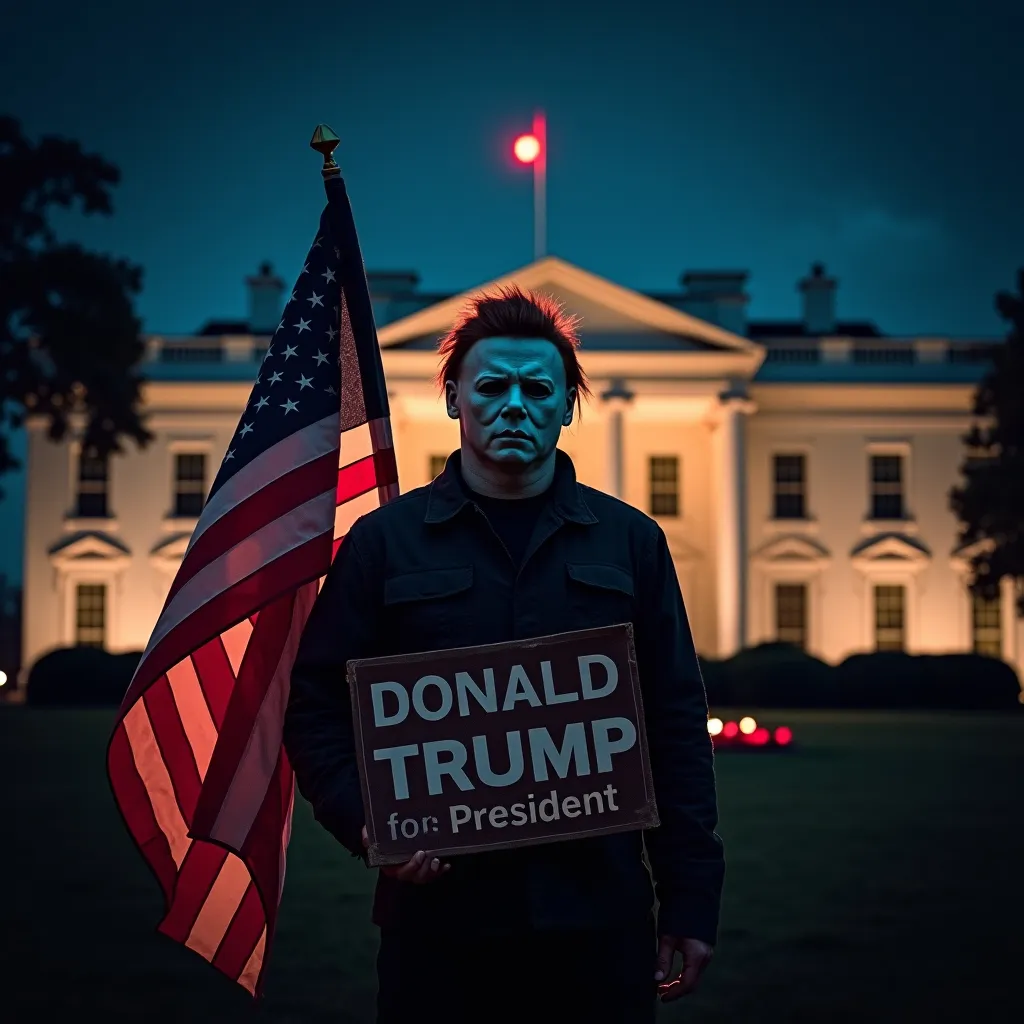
[139,487,337,665]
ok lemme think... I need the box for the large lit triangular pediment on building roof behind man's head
[378,256,763,356]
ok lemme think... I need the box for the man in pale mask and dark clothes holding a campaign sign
[285,289,724,1024]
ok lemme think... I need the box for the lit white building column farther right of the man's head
[715,392,754,657]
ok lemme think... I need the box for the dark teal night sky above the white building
[0,0,1024,573]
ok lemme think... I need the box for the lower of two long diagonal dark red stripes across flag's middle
[127,532,332,702]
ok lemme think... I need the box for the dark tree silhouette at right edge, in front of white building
[949,269,1024,615]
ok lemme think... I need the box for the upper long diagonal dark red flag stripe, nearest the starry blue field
[165,451,338,607]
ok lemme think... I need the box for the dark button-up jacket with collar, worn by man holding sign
[285,452,725,943]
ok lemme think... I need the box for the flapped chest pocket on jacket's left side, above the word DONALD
[384,565,473,653]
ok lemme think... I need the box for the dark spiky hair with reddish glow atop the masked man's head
[437,285,590,410]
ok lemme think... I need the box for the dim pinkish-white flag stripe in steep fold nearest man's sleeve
[210,584,316,850]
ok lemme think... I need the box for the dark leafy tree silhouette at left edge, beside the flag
[0,116,152,494]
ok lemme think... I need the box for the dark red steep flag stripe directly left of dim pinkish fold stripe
[195,591,295,835]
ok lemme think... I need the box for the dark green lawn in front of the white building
[0,708,1024,1024]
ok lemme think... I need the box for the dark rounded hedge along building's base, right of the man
[700,643,1021,711]
